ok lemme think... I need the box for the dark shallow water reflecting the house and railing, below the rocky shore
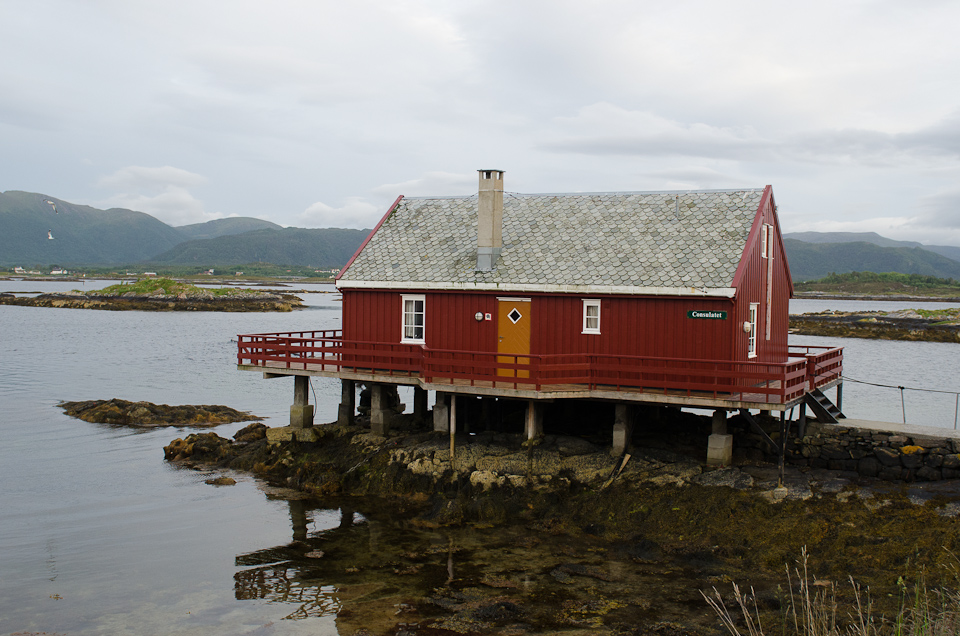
[234,500,758,634]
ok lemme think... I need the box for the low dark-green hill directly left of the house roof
[151,227,370,268]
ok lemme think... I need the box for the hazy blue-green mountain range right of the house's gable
[783,238,960,281]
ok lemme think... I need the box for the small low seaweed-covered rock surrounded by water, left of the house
[57,399,263,428]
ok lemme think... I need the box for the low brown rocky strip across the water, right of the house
[790,309,960,342]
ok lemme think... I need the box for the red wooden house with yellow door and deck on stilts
[238,170,843,463]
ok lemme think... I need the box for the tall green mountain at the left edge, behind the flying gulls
[0,190,183,267]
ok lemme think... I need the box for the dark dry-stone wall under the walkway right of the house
[734,420,960,481]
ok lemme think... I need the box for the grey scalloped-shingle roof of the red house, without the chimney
[338,189,763,296]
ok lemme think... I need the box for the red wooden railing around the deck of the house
[237,330,843,404]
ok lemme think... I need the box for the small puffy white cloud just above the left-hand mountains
[97,166,214,226]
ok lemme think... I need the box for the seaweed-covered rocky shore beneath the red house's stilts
[164,414,960,634]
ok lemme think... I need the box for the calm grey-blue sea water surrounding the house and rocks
[0,288,960,635]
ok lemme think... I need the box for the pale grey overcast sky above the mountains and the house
[0,0,960,245]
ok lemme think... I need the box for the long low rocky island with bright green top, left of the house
[0,278,304,311]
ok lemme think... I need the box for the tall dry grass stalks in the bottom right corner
[700,548,960,636]
